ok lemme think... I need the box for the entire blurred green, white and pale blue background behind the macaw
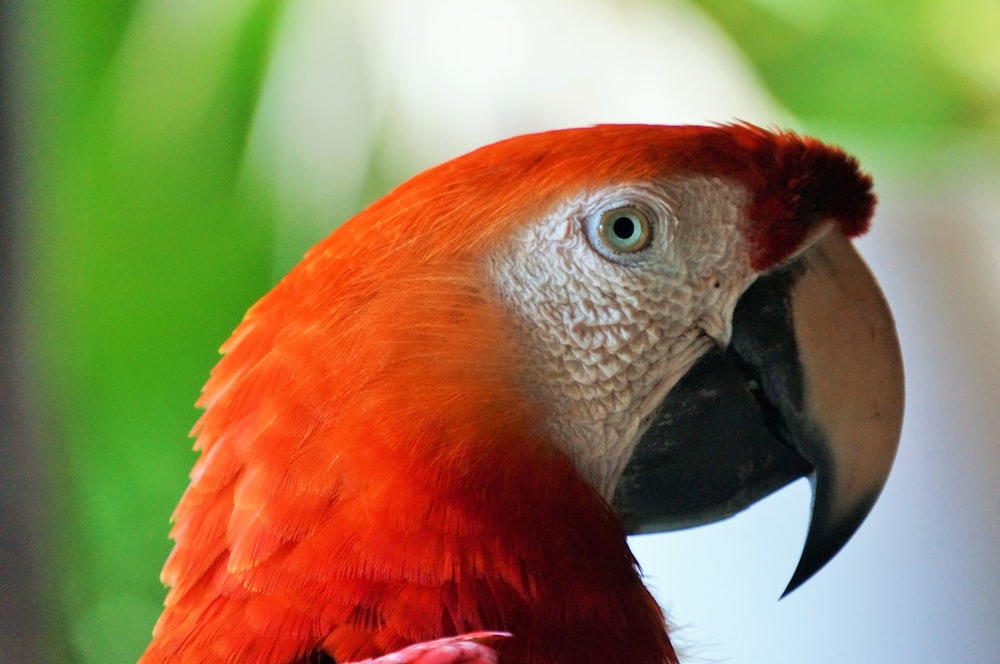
[0,0,1000,664]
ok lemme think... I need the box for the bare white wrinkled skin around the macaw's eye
[489,177,756,501]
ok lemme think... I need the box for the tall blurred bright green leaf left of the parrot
[25,0,281,662]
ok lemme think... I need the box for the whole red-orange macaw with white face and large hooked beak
[140,124,903,664]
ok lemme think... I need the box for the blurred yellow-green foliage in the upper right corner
[696,0,1000,143]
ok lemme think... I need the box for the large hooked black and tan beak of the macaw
[612,228,903,596]
